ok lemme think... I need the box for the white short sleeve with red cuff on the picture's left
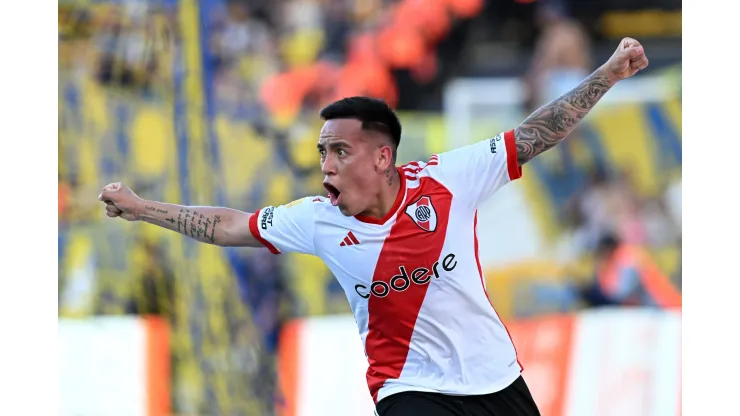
[249,198,315,254]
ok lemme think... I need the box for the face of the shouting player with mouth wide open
[317,119,383,216]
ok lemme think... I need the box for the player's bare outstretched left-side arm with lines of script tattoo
[98,183,262,247]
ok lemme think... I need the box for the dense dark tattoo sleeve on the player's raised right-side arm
[514,71,614,165]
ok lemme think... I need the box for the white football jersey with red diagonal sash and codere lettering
[250,131,522,403]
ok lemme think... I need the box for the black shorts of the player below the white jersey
[376,376,540,416]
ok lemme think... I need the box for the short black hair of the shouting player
[319,97,401,160]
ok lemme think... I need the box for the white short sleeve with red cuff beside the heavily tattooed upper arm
[435,130,522,207]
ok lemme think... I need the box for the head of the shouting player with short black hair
[318,97,401,216]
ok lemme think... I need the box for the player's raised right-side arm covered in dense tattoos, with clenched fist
[514,38,648,166]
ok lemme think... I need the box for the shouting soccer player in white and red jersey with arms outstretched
[98,38,648,416]
